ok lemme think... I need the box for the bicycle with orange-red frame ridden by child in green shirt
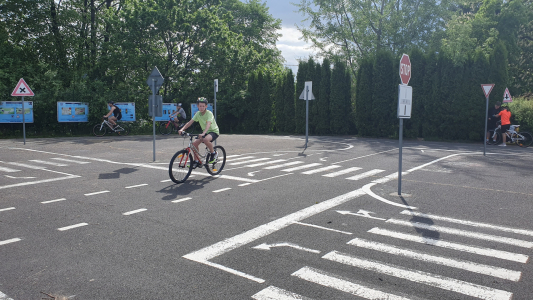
[168,132,226,183]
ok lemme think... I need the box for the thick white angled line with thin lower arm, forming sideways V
[183,189,364,283]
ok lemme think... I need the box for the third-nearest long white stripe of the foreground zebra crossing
[322,251,513,300]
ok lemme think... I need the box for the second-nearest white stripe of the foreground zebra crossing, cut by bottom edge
[291,267,409,300]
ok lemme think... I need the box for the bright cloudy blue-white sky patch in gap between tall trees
[262,0,313,74]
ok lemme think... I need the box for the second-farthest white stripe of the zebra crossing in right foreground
[386,219,533,248]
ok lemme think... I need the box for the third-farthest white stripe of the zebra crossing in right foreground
[368,227,529,264]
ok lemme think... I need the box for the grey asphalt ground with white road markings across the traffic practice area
[0,135,533,300]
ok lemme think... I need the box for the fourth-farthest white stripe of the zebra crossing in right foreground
[347,238,522,281]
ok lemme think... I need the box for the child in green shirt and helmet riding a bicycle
[178,97,220,168]
